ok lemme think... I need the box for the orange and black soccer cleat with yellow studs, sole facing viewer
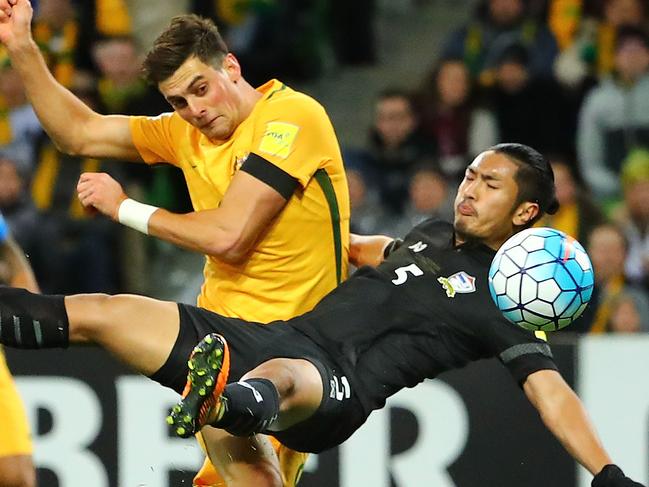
[167,333,230,438]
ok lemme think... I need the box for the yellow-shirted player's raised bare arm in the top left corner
[0,0,140,161]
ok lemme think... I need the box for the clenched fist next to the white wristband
[77,172,128,221]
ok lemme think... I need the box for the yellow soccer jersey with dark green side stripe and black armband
[130,80,349,323]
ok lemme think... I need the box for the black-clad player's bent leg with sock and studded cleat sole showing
[167,334,323,438]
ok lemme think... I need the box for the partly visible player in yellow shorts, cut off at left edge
[0,214,38,487]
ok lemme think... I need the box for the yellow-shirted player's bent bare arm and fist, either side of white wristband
[77,171,286,264]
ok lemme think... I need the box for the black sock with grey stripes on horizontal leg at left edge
[0,286,69,348]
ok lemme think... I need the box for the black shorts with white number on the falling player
[151,304,366,453]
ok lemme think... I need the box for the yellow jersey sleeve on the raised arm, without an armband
[129,112,180,164]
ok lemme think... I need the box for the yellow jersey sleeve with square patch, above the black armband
[251,97,338,187]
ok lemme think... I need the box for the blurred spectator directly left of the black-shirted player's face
[392,161,455,237]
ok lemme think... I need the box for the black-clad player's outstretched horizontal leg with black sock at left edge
[0,287,180,376]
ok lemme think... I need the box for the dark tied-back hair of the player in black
[488,143,559,227]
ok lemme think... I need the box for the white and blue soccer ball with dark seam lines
[489,228,594,331]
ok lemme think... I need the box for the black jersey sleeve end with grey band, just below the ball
[488,317,558,385]
